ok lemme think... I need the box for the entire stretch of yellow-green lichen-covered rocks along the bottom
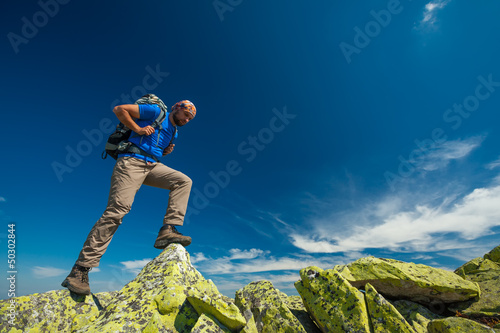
[0,241,500,333]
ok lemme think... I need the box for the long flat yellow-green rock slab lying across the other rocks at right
[334,257,480,304]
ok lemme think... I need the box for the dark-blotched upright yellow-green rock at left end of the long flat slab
[295,266,370,333]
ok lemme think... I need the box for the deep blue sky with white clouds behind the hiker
[0,0,500,298]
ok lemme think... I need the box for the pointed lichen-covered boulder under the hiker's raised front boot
[77,244,218,333]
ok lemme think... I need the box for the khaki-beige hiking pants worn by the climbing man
[76,157,192,267]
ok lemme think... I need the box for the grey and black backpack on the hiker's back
[101,94,170,161]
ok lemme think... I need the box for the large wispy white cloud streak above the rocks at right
[290,180,500,253]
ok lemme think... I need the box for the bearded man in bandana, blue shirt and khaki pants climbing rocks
[61,95,196,295]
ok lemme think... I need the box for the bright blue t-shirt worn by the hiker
[118,104,178,162]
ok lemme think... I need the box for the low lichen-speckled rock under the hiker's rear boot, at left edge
[0,290,108,332]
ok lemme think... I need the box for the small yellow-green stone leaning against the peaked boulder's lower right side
[187,290,246,330]
